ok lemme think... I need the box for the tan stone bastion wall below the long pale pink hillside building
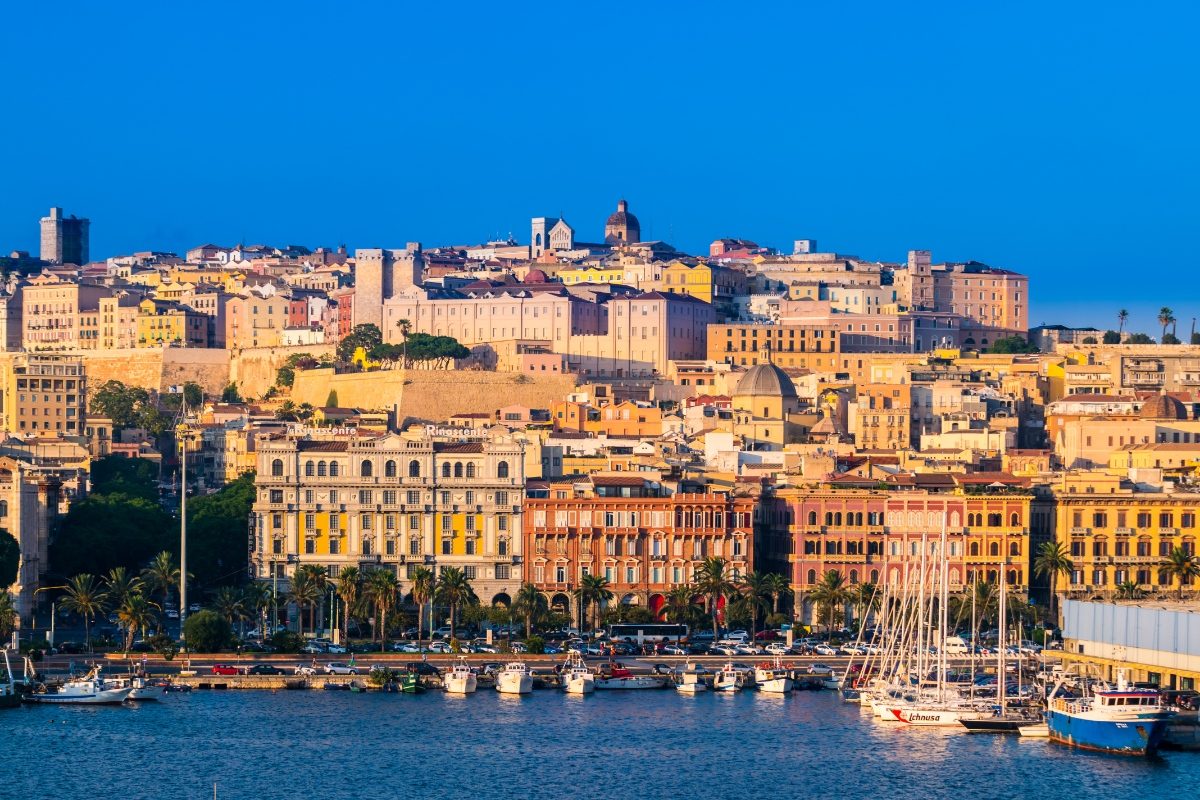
[290,369,575,422]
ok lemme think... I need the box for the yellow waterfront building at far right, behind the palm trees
[1055,471,1200,597]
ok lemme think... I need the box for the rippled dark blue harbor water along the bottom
[0,690,1200,800]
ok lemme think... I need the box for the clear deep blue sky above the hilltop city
[0,1,1200,332]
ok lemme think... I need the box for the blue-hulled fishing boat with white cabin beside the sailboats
[1046,670,1171,756]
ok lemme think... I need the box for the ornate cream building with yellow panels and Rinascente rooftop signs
[251,432,524,603]
